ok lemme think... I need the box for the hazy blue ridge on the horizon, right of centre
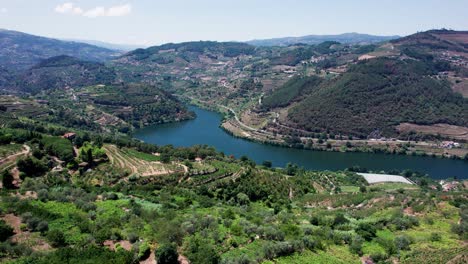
[246,33,399,46]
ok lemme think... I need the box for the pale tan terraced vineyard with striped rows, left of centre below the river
[104,145,184,180]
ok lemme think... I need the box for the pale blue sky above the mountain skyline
[0,0,468,45]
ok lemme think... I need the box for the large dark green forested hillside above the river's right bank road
[287,58,468,137]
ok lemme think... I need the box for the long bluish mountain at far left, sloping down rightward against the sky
[0,29,120,70]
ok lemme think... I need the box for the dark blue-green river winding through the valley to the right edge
[134,106,468,179]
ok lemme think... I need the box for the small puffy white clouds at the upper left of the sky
[55,2,132,18]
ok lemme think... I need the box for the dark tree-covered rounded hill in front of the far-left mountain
[15,55,116,94]
